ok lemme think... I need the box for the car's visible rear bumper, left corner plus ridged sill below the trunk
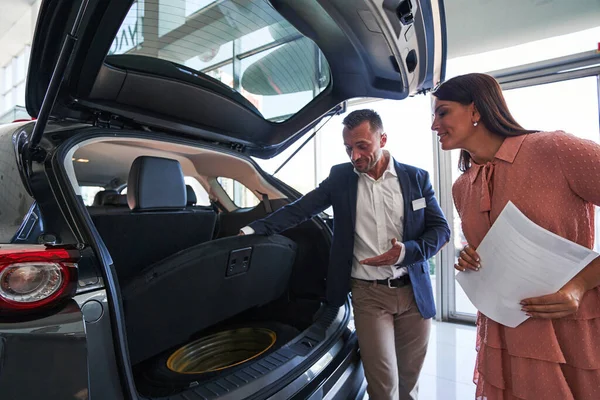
[0,296,364,400]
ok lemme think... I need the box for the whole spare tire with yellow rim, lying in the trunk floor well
[140,322,300,388]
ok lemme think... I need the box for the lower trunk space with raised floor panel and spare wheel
[110,223,348,398]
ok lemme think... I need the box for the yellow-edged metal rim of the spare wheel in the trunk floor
[167,328,277,374]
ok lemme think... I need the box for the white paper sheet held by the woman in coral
[456,202,598,328]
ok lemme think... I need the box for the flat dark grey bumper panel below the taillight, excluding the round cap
[0,301,89,400]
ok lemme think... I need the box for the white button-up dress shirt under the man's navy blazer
[241,150,408,280]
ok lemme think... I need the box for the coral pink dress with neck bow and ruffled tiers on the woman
[452,131,600,400]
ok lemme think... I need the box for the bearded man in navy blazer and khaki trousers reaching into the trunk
[240,110,450,400]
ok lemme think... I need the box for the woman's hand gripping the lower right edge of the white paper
[521,279,585,319]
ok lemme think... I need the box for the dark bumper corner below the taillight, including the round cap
[0,289,124,400]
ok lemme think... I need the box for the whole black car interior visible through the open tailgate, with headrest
[65,134,337,396]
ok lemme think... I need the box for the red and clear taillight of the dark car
[0,245,79,314]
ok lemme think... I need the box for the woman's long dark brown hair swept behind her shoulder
[432,73,538,172]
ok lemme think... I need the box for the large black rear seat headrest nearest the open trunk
[127,156,186,211]
